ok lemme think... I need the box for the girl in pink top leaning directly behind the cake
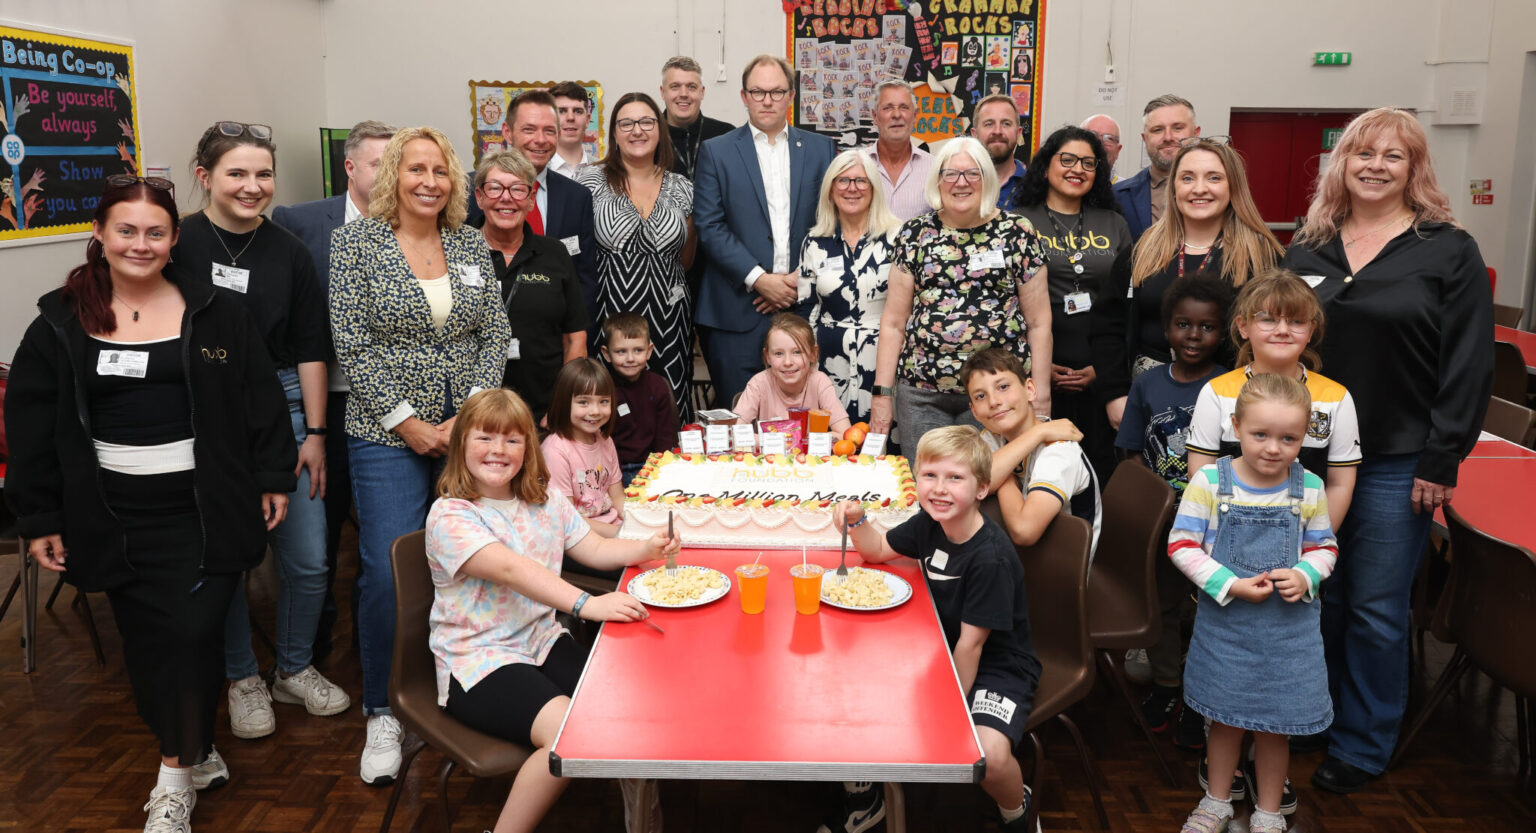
[731,312,852,435]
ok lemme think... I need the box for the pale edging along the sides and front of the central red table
[550,550,986,784]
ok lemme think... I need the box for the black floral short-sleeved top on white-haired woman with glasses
[891,211,1046,393]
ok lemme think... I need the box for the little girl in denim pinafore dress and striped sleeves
[1167,373,1338,833]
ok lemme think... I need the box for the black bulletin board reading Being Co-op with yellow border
[0,26,140,243]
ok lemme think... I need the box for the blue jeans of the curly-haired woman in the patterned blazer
[347,436,442,715]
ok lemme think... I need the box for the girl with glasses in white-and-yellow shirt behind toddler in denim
[1187,267,1361,524]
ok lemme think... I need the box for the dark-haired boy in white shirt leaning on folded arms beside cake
[960,347,1100,559]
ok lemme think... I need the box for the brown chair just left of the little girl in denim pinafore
[1087,460,1178,787]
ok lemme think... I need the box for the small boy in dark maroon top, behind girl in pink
[602,312,677,486]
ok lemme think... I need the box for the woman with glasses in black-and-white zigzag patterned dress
[576,92,697,423]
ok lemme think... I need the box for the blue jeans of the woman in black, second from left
[224,367,326,679]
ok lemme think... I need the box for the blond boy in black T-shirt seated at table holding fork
[831,427,1040,830]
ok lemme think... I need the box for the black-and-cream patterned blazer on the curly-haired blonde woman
[330,218,511,447]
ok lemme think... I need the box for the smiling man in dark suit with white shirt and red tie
[503,89,601,336]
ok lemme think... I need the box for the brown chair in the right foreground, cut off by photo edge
[1387,507,1536,773]
